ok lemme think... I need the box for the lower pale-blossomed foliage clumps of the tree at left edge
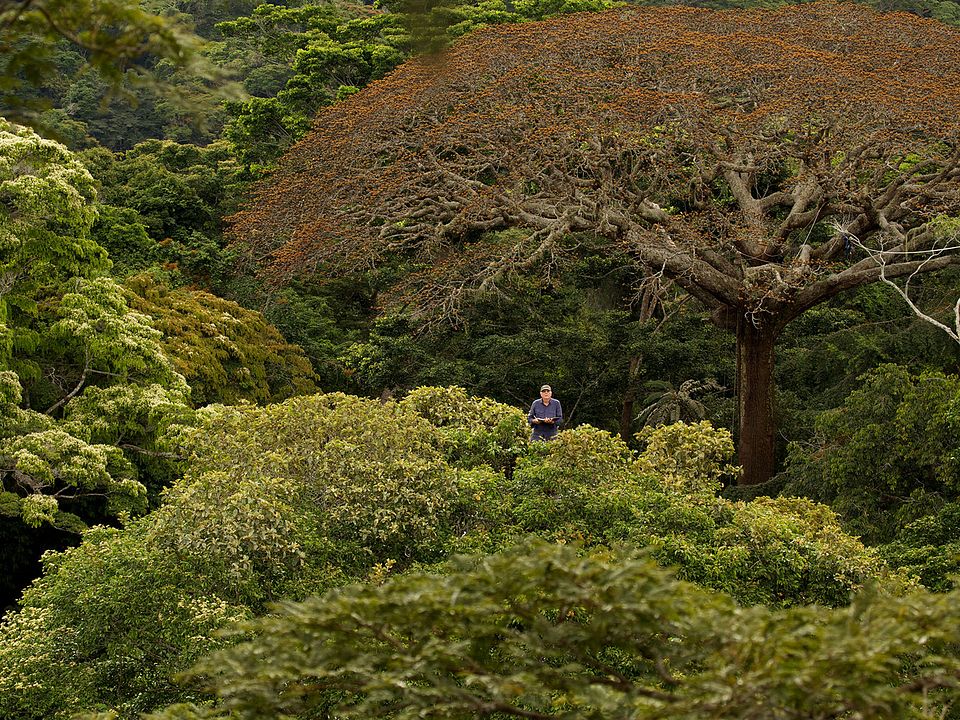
[0,278,188,526]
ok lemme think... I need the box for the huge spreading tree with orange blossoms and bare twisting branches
[234,3,960,484]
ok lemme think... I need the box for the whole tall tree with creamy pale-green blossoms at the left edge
[0,124,189,530]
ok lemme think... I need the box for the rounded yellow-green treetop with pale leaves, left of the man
[166,394,464,592]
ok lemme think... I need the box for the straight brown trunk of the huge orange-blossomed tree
[737,319,777,485]
